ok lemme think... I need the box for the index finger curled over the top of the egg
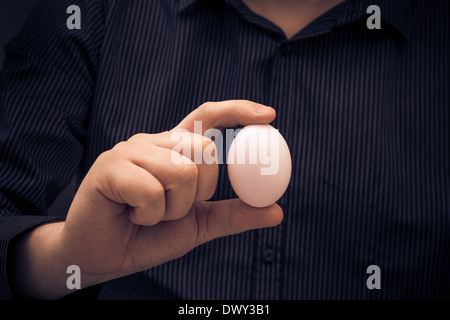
[175,100,276,135]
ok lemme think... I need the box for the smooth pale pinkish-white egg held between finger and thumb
[227,124,292,207]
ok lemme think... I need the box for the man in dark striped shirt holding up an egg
[0,0,450,299]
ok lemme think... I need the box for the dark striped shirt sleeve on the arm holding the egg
[0,0,105,299]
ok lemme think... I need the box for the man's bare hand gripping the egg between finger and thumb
[8,100,283,298]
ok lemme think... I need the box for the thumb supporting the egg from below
[195,199,283,245]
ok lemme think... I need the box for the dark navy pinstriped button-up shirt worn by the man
[0,0,450,299]
